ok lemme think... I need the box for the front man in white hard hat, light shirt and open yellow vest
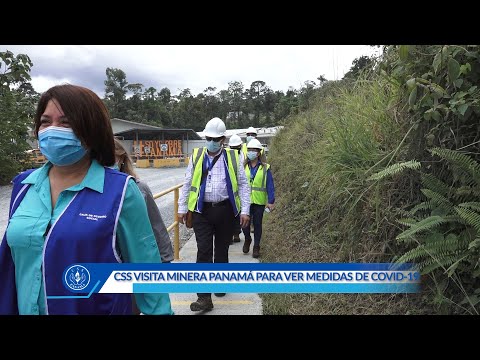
[178,117,250,311]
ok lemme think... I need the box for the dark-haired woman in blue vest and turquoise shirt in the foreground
[0,84,173,315]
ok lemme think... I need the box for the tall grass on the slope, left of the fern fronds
[262,79,431,314]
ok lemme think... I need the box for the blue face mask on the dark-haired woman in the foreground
[38,126,87,166]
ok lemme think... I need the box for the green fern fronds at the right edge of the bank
[370,148,480,308]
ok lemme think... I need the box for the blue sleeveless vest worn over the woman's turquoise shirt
[0,168,132,315]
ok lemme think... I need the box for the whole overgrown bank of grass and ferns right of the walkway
[263,45,480,314]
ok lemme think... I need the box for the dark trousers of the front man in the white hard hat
[193,202,234,297]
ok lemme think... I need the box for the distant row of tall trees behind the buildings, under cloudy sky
[104,67,320,131]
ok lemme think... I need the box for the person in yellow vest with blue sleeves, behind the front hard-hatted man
[242,139,275,258]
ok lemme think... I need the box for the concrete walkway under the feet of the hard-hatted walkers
[170,234,262,315]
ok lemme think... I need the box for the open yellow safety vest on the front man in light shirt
[188,147,241,215]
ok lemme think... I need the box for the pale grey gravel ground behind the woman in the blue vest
[0,167,193,248]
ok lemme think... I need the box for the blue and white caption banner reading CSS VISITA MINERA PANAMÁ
[48,263,420,298]
